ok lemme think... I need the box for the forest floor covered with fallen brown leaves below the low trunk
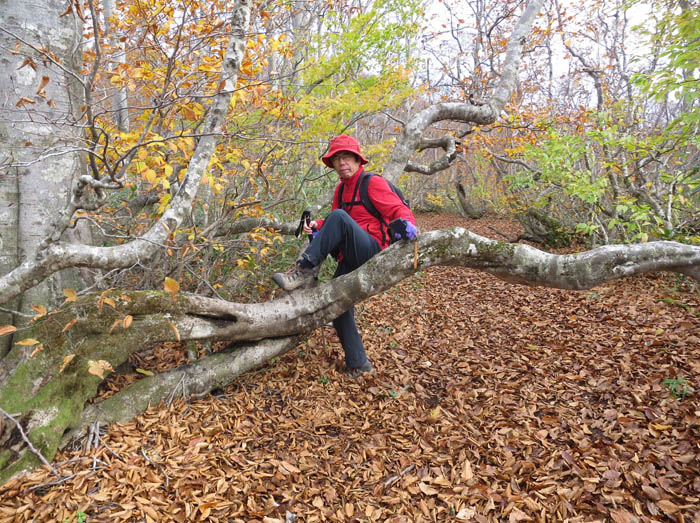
[0,216,700,523]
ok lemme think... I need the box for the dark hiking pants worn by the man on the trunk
[301,209,381,369]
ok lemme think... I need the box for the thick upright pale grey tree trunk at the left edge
[0,0,87,321]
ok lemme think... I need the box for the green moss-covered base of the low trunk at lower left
[0,291,211,483]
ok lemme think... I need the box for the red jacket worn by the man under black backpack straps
[316,167,416,249]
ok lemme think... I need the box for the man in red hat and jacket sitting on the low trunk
[272,134,418,378]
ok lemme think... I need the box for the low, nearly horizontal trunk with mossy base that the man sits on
[0,228,700,481]
